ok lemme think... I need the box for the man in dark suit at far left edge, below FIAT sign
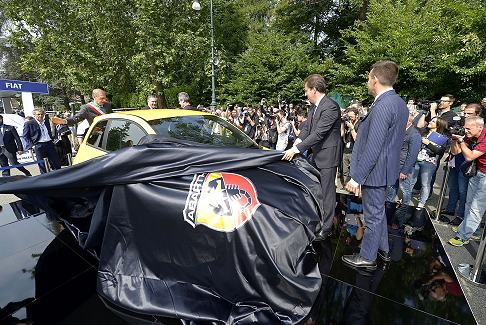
[0,115,32,176]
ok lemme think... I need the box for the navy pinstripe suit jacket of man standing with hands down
[349,90,408,186]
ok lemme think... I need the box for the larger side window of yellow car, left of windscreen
[102,119,147,151]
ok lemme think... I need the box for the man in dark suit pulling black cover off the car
[282,74,341,240]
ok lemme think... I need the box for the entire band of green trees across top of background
[0,0,486,107]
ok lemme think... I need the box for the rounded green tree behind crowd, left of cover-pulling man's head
[223,32,325,104]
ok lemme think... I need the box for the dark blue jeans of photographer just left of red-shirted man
[446,167,469,219]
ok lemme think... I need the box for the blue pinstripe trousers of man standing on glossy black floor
[359,185,389,261]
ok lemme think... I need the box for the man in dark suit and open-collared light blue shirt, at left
[24,108,61,174]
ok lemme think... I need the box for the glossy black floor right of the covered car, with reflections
[305,194,476,324]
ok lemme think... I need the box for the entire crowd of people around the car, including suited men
[0,61,486,268]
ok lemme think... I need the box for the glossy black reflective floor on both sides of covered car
[0,195,475,324]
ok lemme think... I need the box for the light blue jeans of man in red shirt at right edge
[457,170,486,240]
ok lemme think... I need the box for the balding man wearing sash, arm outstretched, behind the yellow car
[52,89,112,126]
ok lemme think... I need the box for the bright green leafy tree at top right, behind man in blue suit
[334,0,486,101]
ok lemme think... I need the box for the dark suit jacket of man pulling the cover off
[297,96,341,168]
